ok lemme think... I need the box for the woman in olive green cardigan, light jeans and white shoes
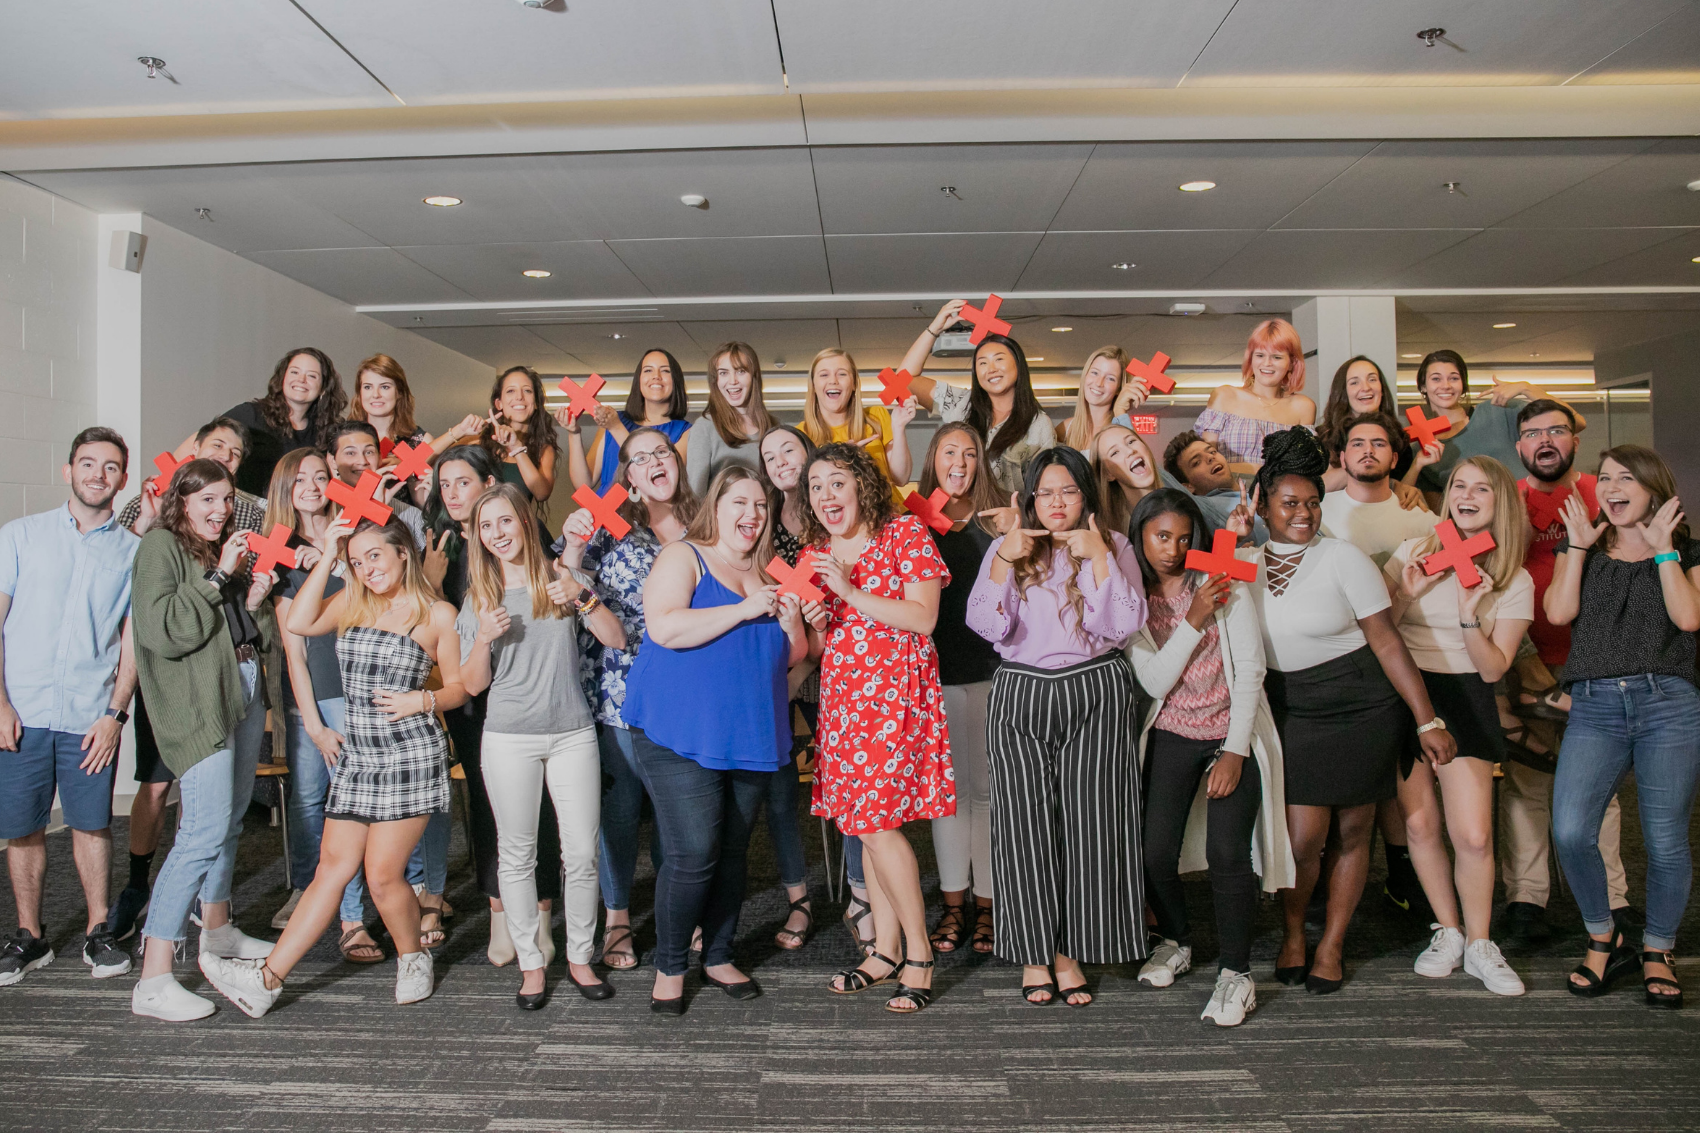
[131,459,277,1022]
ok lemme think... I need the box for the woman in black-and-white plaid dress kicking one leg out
[201,515,466,1019]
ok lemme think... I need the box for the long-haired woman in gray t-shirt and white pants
[456,483,626,1011]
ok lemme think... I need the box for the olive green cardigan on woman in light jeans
[129,527,277,777]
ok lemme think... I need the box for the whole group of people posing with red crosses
[0,301,1700,1026]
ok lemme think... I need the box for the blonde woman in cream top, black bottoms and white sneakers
[1386,456,1535,995]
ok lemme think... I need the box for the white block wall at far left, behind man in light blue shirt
[0,177,97,524]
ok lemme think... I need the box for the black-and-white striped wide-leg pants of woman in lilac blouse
[986,652,1146,965]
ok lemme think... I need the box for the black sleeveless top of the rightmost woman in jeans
[1557,539,1700,686]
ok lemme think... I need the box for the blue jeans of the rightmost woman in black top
[1552,674,1700,951]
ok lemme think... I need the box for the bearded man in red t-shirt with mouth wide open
[1499,398,1629,944]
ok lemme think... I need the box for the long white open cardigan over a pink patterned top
[1127,584,1295,893]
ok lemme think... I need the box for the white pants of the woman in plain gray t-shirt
[481,726,602,971]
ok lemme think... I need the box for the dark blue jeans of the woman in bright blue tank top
[631,728,774,975]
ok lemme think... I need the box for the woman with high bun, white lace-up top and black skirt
[1251,425,1457,995]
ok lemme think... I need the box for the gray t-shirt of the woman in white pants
[454,587,595,735]
